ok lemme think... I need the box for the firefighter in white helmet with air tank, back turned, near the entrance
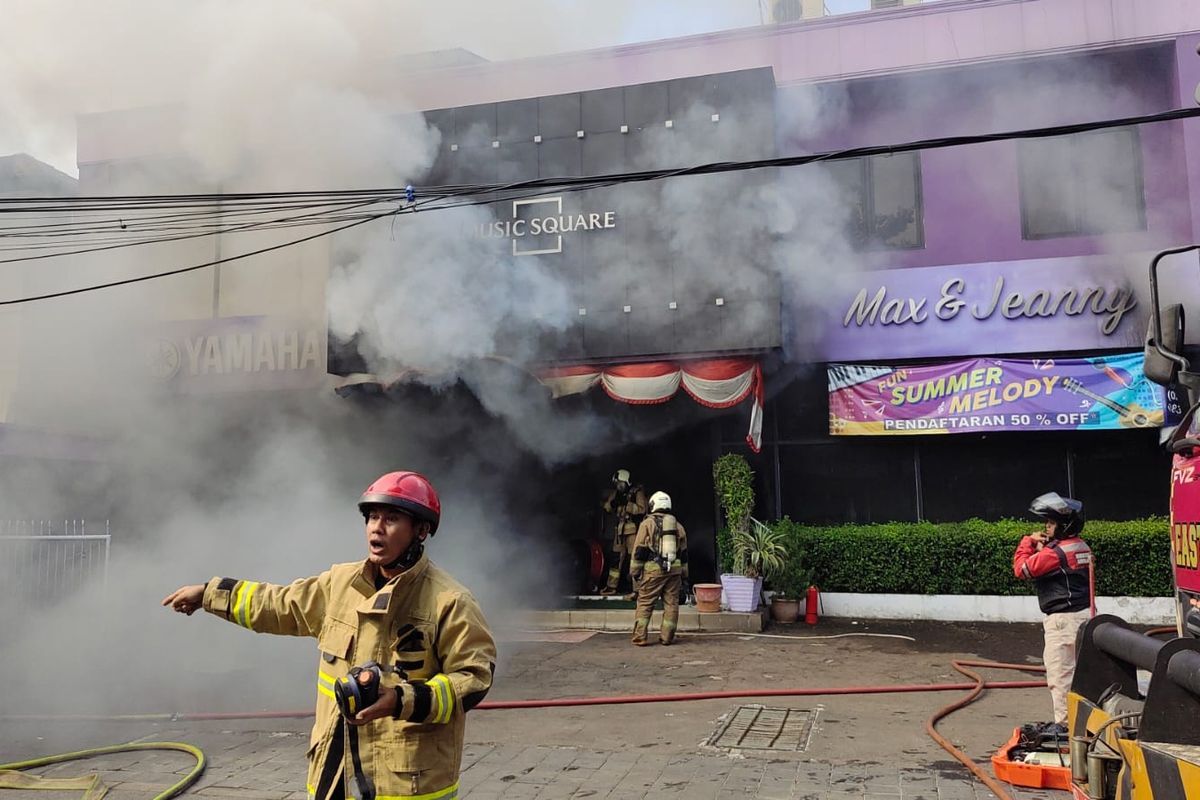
[630,492,688,645]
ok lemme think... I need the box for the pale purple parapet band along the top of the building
[395,0,1200,109]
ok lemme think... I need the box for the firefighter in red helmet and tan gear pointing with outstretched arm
[162,471,496,800]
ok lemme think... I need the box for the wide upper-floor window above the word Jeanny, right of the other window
[1018,128,1146,239]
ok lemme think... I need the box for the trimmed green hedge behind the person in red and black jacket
[748,517,1171,597]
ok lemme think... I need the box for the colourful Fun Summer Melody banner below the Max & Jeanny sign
[829,353,1163,435]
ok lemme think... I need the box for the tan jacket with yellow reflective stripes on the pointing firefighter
[204,555,496,800]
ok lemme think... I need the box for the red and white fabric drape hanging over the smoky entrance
[538,359,763,452]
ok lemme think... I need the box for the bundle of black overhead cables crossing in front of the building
[0,108,1200,306]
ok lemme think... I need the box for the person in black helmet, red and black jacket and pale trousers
[1013,492,1092,735]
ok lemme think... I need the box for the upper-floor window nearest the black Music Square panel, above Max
[826,152,925,249]
